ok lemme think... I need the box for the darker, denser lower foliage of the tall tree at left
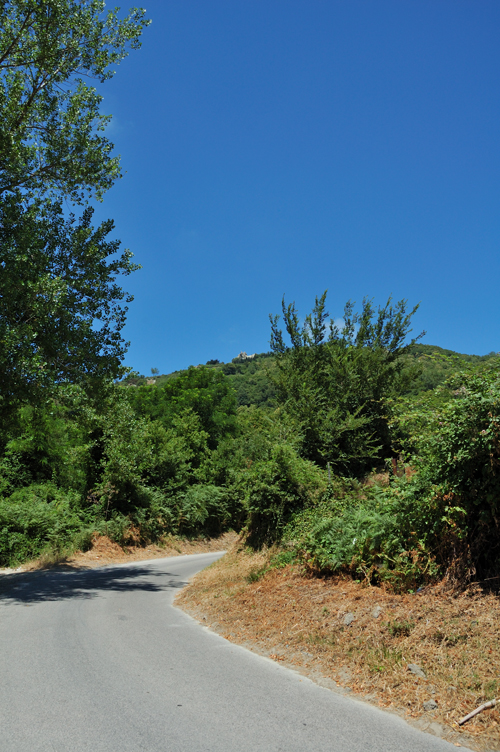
[0,198,137,418]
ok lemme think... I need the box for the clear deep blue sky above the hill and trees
[91,0,500,373]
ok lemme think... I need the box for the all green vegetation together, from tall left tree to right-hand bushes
[0,0,500,592]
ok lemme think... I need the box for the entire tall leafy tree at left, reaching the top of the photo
[0,0,148,418]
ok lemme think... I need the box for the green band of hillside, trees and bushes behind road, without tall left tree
[0,282,500,588]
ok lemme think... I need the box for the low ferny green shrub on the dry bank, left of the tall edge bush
[284,477,443,590]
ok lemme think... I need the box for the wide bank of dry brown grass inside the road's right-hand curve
[176,545,500,750]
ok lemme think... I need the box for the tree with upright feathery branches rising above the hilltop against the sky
[270,292,423,475]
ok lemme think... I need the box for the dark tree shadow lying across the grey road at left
[0,566,186,604]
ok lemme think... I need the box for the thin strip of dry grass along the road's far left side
[0,533,238,574]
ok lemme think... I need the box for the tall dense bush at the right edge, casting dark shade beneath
[402,362,500,579]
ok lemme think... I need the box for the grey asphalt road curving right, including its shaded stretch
[0,554,468,752]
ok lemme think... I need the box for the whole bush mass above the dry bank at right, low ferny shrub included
[285,368,500,588]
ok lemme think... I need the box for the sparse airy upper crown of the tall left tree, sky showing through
[0,0,148,202]
